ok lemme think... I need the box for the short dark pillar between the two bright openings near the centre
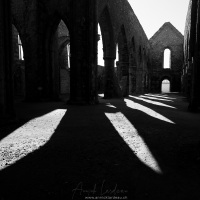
[104,57,122,98]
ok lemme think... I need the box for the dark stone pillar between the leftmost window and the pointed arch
[21,1,43,101]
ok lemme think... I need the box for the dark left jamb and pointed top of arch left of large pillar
[43,14,70,99]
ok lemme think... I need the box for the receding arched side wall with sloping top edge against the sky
[99,0,149,93]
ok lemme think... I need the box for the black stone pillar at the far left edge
[0,0,15,118]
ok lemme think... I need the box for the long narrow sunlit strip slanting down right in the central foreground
[105,112,162,174]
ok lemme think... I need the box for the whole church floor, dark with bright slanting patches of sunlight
[0,93,200,200]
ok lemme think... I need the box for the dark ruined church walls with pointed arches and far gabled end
[0,0,199,116]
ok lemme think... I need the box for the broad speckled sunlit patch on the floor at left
[0,109,67,170]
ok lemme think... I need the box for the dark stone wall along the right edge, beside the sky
[182,0,200,111]
